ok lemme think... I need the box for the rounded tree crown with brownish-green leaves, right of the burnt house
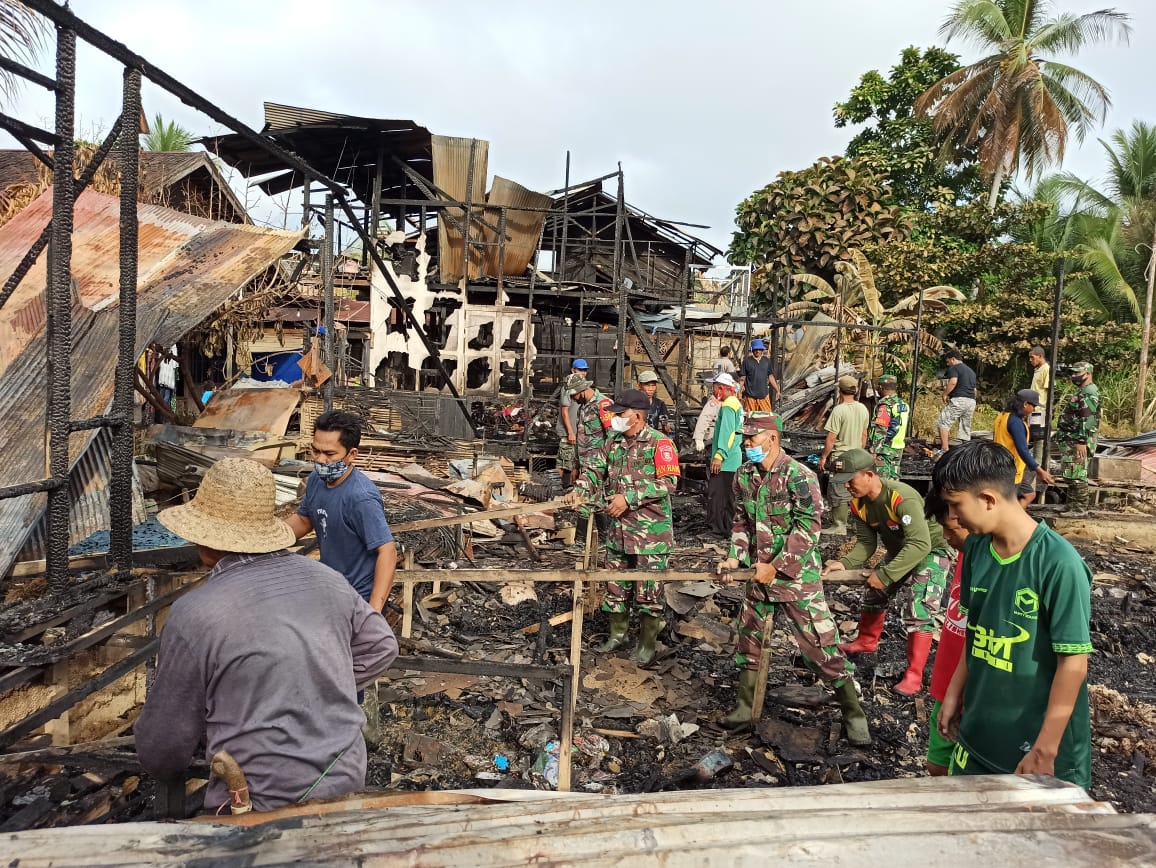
[727,157,909,297]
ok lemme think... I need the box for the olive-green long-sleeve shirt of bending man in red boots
[839,480,950,585]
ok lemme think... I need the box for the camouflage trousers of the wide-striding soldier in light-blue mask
[734,581,855,687]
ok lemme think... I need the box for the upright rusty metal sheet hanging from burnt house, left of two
[430,135,490,283]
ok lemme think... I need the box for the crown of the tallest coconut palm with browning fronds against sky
[916,0,1132,210]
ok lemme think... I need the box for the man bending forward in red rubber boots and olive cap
[825,450,955,696]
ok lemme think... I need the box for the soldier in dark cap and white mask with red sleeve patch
[572,390,681,666]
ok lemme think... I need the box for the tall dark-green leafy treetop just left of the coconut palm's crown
[835,45,984,210]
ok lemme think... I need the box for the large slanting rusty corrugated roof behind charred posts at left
[0,190,302,574]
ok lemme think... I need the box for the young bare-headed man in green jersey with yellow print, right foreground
[932,440,1091,789]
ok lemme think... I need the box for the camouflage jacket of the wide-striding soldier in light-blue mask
[729,452,823,601]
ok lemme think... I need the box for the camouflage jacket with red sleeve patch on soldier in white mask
[575,428,682,555]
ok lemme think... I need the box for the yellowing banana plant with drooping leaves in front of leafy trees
[786,250,966,377]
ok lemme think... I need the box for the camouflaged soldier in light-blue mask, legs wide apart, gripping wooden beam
[718,413,870,744]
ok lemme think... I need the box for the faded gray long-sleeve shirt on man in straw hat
[135,551,398,810]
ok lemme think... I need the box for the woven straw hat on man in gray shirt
[157,458,296,555]
